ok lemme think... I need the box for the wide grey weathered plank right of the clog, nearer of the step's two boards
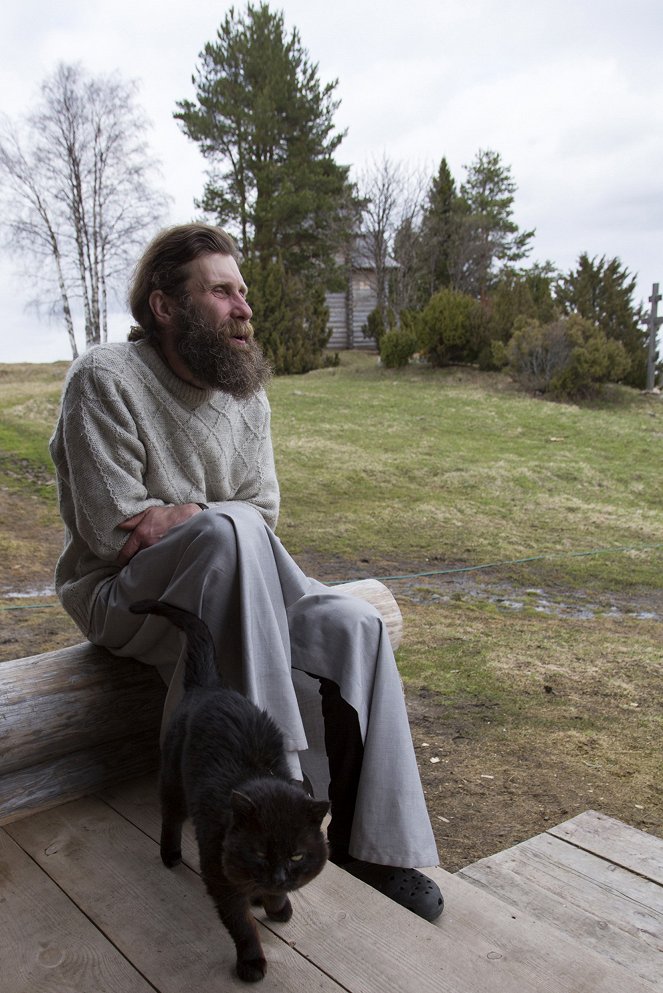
[458,834,663,990]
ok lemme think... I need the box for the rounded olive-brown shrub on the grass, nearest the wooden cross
[506,316,630,399]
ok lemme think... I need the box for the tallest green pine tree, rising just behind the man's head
[175,3,356,369]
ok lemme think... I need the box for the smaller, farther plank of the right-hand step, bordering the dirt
[548,810,663,886]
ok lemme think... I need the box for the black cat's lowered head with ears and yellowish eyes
[223,779,329,893]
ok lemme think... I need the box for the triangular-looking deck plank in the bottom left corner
[0,830,153,993]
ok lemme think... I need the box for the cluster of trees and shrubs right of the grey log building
[363,151,647,396]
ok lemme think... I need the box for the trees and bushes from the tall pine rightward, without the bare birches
[175,4,646,395]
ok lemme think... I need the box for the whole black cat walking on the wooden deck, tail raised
[130,600,329,981]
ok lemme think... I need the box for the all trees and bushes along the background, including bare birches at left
[0,3,646,394]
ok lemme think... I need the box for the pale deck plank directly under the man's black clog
[98,777,651,993]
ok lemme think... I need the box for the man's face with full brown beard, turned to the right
[172,255,271,399]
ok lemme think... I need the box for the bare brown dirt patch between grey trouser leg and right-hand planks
[408,693,663,872]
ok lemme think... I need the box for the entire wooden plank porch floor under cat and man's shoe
[0,774,663,993]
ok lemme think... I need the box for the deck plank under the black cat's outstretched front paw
[5,799,339,993]
